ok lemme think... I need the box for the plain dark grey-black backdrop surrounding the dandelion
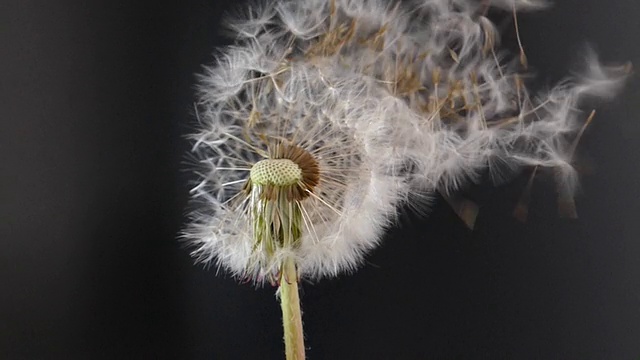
[0,0,640,359]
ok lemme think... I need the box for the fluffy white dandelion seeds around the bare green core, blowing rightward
[186,0,626,282]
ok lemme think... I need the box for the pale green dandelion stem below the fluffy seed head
[280,258,305,360]
